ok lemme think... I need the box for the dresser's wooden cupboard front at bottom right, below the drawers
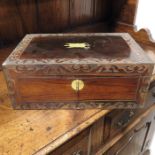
[103,109,155,155]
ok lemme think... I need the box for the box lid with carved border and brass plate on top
[3,33,154,76]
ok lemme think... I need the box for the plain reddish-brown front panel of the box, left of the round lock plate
[16,78,77,103]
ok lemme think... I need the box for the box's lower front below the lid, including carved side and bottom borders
[5,65,150,109]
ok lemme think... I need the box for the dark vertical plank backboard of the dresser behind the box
[0,0,108,46]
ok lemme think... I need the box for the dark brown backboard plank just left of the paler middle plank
[38,0,69,32]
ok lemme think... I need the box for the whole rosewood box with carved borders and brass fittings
[3,33,154,109]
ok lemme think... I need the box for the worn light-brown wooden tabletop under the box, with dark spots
[0,72,108,155]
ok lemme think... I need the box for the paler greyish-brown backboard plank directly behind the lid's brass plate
[70,0,93,26]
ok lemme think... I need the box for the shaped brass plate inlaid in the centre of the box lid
[64,43,90,49]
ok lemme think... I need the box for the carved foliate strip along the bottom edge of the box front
[14,101,144,109]
